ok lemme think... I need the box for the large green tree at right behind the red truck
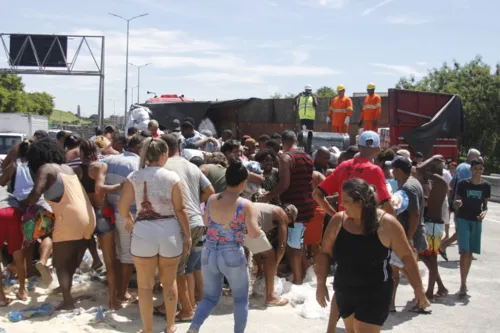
[396,56,500,170]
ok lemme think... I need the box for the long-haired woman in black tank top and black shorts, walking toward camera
[316,178,430,333]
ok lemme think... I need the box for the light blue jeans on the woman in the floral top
[191,240,250,333]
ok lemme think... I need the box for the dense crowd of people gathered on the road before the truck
[0,118,490,333]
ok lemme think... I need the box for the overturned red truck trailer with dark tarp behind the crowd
[142,89,464,159]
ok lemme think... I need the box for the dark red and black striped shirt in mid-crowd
[280,148,314,223]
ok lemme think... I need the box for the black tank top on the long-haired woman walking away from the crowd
[333,214,392,290]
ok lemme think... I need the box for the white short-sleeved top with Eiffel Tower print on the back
[128,167,181,221]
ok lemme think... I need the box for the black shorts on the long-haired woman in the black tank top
[335,282,394,326]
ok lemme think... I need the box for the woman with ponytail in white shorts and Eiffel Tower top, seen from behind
[118,138,191,333]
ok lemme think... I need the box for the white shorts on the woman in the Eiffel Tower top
[130,218,183,258]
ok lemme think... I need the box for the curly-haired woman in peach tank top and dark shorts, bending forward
[23,138,95,310]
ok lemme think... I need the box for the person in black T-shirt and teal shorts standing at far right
[456,157,491,297]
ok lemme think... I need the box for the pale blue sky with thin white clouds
[0,0,500,117]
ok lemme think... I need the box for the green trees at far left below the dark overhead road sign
[0,74,54,116]
